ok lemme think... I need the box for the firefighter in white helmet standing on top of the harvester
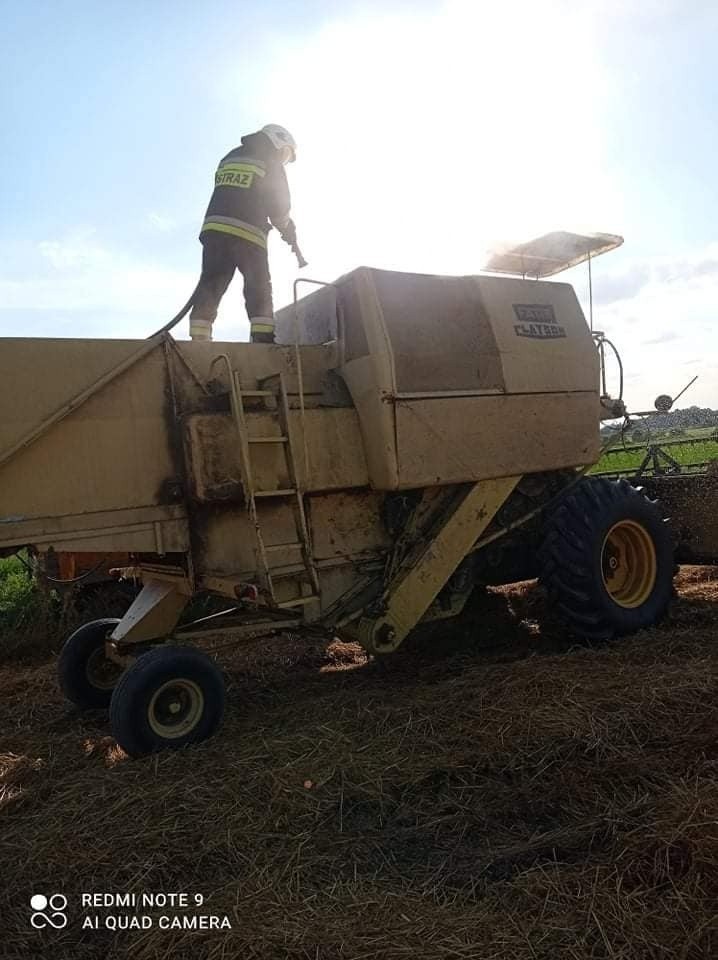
[189,123,297,343]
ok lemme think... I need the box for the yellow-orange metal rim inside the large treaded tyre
[601,520,658,610]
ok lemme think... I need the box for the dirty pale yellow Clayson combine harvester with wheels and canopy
[0,233,688,756]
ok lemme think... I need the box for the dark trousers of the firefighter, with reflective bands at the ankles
[189,230,274,342]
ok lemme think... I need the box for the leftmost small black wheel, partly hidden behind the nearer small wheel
[57,617,123,709]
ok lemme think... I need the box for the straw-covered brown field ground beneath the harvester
[0,568,718,960]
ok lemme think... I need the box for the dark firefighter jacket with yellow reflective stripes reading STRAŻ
[200,133,292,248]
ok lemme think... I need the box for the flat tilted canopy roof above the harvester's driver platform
[484,230,623,280]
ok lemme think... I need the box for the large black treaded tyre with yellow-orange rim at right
[539,477,675,640]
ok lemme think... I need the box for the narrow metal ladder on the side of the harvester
[230,370,319,607]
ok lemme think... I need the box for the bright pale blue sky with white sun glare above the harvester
[0,0,718,410]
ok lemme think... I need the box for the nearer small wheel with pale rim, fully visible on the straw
[110,646,224,757]
